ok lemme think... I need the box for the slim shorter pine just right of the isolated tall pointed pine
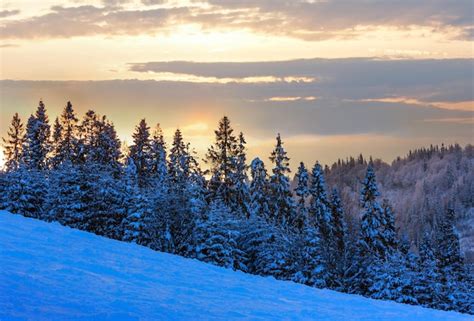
[292,162,310,231]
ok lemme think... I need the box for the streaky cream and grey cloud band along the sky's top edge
[0,0,473,41]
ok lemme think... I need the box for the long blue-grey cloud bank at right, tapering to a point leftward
[129,58,474,103]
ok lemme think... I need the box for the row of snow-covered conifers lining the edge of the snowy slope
[0,102,473,313]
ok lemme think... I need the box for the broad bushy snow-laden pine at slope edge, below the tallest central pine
[196,199,246,270]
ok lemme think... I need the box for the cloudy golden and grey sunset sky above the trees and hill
[0,0,474,169]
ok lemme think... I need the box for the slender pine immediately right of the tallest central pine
[230,132,250,218]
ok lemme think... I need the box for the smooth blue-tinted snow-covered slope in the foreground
[0,212,473,321]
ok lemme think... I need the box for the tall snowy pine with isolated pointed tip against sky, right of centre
[269,134,295,227]
